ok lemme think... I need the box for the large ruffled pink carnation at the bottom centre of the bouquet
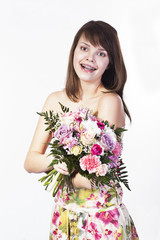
[80,154,101,174]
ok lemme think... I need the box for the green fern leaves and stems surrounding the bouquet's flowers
[37,102,130,196]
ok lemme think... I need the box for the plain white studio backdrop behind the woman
[0,0,160,240]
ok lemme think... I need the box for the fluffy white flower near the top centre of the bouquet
[81,119,101,135]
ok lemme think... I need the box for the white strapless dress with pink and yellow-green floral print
[49,183,139,240]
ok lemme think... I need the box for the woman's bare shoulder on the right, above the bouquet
[98,93,125,127]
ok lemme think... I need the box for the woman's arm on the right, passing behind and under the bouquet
[72,94,125,189]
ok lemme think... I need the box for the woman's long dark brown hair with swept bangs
[65,21,131,120]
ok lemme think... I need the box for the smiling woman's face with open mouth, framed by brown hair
[73,35,109,82]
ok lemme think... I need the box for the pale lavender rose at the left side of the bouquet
[54,124,72,141]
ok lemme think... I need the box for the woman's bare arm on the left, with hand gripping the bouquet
[24,93,68,174]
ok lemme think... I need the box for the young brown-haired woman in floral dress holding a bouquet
[25,21,139,240]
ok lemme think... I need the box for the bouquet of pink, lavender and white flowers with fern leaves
[38,103,130,196]
